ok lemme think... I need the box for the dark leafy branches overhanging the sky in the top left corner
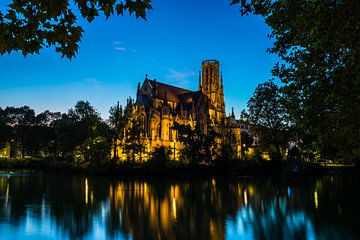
[0,0,152,59]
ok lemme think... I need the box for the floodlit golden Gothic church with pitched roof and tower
[118,60,241,160]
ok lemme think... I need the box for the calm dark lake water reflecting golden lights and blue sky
[0,172,360,239]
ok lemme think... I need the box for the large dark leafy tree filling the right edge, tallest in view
[232,0,360,163]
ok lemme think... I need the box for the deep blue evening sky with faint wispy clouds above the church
[0,0,277,118]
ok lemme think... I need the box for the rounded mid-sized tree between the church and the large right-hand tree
[248,81,290,160]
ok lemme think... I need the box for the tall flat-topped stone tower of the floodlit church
[199,60,226,123]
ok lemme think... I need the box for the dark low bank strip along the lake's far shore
[0,157,350,177]
